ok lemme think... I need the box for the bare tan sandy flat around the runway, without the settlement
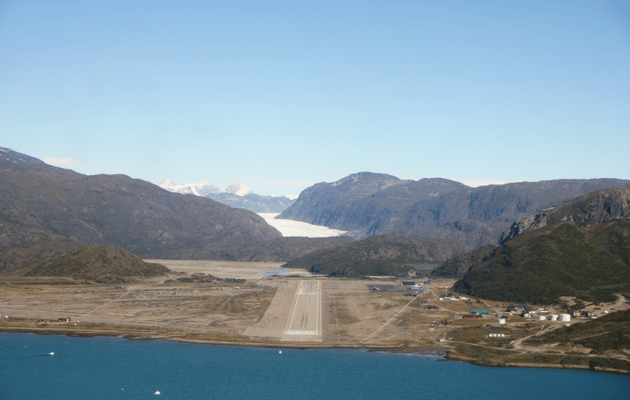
[0,260,460,346]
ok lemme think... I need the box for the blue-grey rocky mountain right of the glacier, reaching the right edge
[279,173,630,249]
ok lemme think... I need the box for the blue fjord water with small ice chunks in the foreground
[0,334,630,400]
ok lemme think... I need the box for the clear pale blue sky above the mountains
[0,0,630,195]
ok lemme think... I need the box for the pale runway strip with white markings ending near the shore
[282,280,322,342]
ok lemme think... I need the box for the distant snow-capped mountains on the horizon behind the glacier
[159,179,294,213]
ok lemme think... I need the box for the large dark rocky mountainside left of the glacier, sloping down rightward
[0,148,281,258]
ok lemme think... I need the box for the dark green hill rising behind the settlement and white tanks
[454,219,630,304]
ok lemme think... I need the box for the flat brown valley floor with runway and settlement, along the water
[0,260,630,374]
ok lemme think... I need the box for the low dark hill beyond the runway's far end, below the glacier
[284,236,465,277]
